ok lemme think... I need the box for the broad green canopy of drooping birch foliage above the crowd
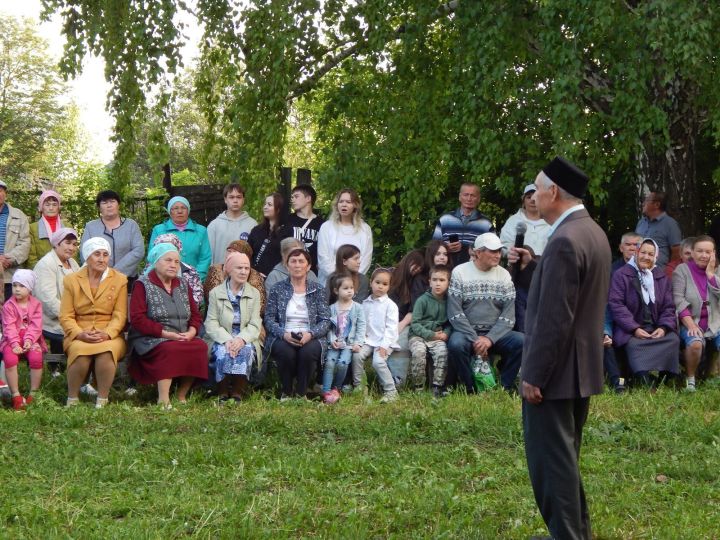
[43,0,720,252]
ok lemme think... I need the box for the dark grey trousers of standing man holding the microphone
[522,398,591,540]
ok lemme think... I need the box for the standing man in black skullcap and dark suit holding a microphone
[519,157,610,539]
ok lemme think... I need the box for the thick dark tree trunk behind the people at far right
[636,104,704,237]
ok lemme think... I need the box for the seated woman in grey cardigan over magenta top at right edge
[672,236,720,392]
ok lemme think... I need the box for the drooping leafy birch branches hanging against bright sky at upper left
[42,0,184,190]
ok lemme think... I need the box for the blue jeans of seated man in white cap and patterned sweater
[448,330,524,394]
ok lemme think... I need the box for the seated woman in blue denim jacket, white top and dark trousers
[265,249,330,400]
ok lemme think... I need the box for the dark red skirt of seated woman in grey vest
[128,338,208,384]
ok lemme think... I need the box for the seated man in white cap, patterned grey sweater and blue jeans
[447,233,523,394]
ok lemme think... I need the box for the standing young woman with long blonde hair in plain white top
[318,188,373,283]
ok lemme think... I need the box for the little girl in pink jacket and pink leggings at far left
[0,270,47,410]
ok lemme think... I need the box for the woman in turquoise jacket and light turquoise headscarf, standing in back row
[148,197,212,280]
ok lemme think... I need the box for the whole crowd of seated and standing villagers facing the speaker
[0,181,720,409]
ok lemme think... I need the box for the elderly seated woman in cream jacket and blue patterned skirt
[205,252,262,402]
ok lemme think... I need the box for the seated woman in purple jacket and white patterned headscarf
[608,238,680,384]
